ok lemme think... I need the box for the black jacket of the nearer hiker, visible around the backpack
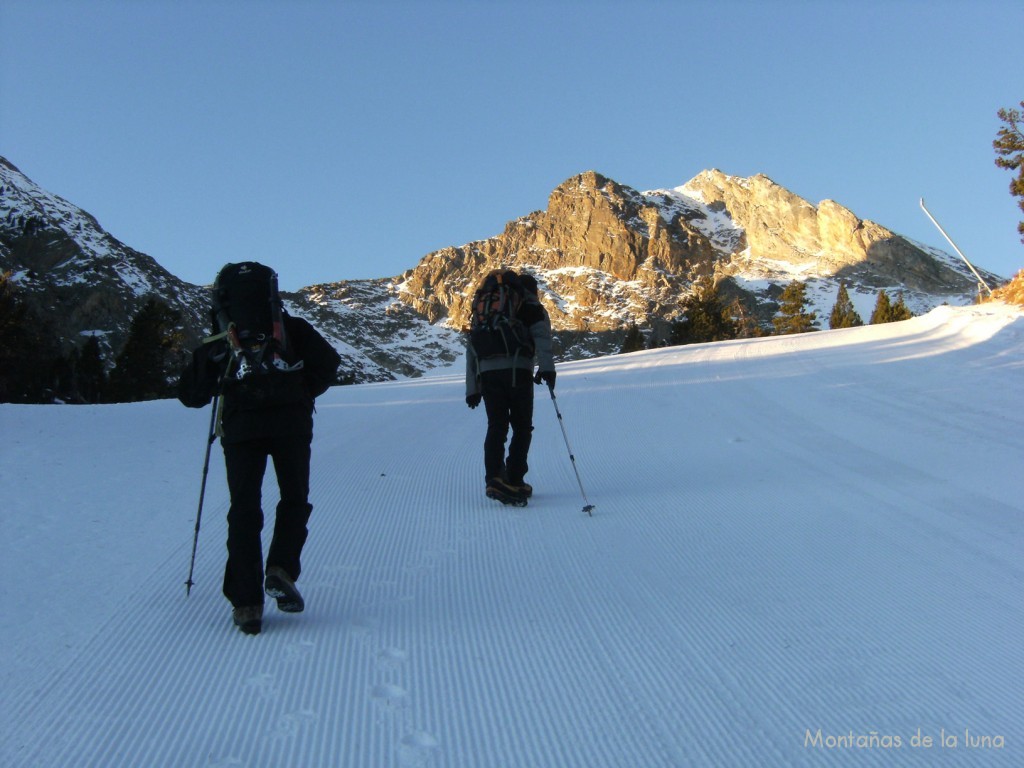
[178,314,341,442]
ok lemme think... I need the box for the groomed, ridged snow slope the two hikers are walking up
[0,304,1024,768]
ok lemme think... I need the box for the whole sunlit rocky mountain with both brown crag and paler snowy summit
[389,169,991,360]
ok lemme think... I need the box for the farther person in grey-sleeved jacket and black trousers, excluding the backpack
[466,271,555,506]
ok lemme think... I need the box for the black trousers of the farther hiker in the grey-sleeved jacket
[480,368,534,485]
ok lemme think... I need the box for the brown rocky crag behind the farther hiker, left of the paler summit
[391,171,729,352]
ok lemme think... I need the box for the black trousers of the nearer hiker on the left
[223,435,312,607]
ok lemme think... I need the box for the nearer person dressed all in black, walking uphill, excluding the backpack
[178,262,340,635]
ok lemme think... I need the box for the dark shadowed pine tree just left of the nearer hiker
[109,298,182,402]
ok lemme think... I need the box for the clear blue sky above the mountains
[0,0,1024,290]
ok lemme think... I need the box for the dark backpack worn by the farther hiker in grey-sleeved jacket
[469,270,534,359]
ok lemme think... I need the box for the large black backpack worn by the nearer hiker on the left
[211,261,302,398]
